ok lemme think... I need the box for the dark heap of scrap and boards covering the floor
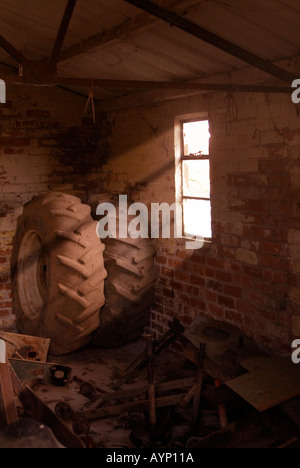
[0,318,300,449]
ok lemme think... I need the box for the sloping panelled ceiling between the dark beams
[0,0,300,99]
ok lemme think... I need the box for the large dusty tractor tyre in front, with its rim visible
[11,192,107,356]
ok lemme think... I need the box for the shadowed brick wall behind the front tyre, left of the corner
[0,87,110,328]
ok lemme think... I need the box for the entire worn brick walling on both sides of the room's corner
[0,84,300,351]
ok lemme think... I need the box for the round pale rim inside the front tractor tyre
[18,231,48,320]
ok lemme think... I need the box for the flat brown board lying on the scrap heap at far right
[226,357,300,412]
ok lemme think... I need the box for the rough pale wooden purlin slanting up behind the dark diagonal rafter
[57,0,197,62]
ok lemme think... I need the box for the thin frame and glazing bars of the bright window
[176,115,212,242]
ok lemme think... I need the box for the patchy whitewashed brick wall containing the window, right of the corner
[98,90,300,352]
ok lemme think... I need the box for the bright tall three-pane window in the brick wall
[176,119,212,239]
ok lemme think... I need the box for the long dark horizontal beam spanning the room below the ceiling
[0,75,292,94]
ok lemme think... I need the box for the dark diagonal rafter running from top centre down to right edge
[124,0,298,83]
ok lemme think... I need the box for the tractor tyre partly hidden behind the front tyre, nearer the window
[89,194,157,348]
